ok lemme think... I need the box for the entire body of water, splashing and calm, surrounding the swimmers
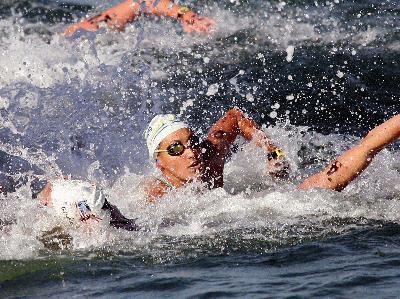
[0,0,400,298]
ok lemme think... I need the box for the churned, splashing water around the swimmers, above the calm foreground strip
[0,1,400,298]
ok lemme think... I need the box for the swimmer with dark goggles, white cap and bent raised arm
[145,108,289,202]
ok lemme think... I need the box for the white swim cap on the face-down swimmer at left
[51,179,105,220]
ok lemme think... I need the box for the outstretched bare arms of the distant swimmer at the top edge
[64,0,215,36]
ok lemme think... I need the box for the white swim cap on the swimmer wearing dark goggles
[144,114,188,159]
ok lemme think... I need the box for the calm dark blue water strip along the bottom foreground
[0,223,400,298]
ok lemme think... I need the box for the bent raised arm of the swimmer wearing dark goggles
[207,108,289,177]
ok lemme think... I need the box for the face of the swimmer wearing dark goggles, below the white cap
[157,128,203,182]
